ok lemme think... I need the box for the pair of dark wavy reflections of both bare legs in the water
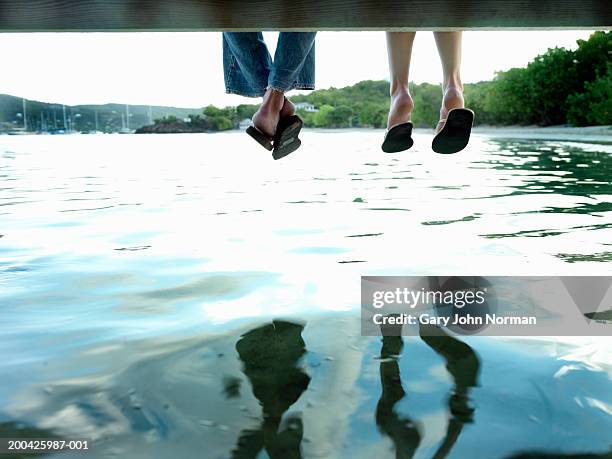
[376,314,480,459]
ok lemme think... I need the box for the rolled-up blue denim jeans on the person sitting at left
[223,32,316,97]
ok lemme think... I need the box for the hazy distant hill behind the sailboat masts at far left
[0,94,202,132]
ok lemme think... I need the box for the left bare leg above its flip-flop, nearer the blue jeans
[387,32,416,128]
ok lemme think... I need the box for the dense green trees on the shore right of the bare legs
[478,32,612,126]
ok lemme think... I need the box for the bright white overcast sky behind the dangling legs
[0,30,593,107]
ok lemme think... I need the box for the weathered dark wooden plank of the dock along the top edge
[0,0,612,32]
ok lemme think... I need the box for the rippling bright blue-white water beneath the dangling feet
[0,131,612,458]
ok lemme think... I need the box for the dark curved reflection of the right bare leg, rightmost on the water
[420,325,480,459]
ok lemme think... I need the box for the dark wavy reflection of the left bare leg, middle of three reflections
[376,325,421,459]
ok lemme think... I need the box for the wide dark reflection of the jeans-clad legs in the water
[232,320,310,459]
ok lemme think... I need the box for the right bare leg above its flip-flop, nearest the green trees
[434,32,464,132]
